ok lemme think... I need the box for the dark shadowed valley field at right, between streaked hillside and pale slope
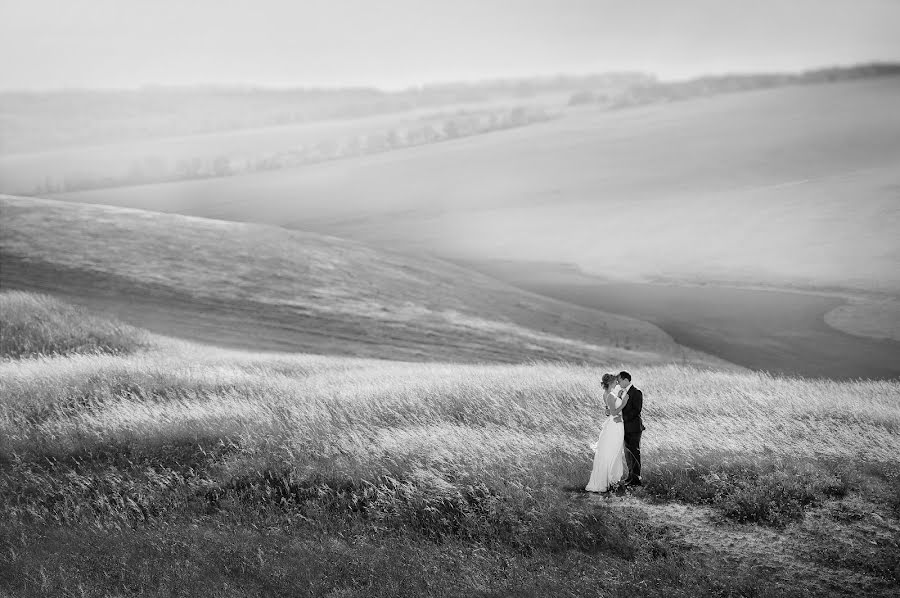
[464,260,900,380]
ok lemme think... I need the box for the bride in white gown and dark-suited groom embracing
[585,372,644,492]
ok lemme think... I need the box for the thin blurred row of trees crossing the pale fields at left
[32,107,555,195]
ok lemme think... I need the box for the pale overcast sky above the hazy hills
[0,0,900,90]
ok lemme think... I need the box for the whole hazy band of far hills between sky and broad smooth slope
[7,64,900,195]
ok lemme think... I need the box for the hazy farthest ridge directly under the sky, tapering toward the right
[0,72,652,153]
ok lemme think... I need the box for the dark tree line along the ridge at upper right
[569,63,900,108]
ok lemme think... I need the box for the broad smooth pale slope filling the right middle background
[52,77,900,295]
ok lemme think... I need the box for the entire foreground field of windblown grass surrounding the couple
[0,293,900,597]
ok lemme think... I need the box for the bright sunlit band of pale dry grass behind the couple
[0,345,900,467]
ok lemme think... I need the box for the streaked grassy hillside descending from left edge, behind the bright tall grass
[0,196,724,365]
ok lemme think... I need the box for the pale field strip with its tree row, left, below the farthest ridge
[0,95,566,196]
